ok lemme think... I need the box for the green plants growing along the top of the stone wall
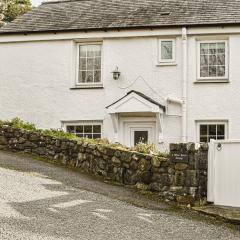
[0,118,168,157]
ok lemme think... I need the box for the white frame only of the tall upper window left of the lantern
[75,42,103,88]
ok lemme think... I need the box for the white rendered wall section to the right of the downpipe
[188,34,240,141]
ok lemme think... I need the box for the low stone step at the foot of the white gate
[193,205,240,225]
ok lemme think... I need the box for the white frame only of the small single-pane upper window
[158,38,176,65]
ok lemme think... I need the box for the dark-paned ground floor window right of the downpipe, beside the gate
[198,122,227,142]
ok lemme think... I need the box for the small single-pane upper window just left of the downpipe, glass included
[158,39,175,63]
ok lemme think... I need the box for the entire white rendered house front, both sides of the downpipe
[0,29,240,143]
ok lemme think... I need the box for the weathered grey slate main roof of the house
[0,0,240,33]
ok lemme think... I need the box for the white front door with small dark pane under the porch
[124,122,156,147]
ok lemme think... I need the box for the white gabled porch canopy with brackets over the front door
[106,90,166,142]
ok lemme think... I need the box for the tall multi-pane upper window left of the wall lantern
[77,44,102,84]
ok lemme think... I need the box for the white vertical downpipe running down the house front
[182,27,188,143]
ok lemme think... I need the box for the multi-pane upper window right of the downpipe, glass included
[198,40,228,80]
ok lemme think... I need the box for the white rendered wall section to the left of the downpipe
[0,37,181,146]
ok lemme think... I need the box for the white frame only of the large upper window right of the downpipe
[197,40,229,82]
